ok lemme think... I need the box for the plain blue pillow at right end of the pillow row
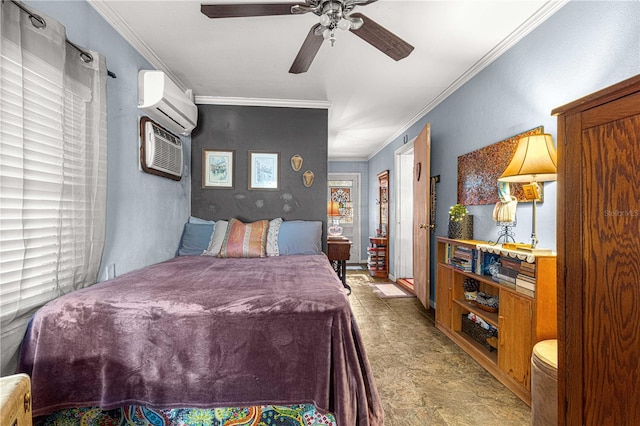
[278,220,322,256]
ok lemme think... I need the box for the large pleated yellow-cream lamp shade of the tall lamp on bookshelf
[498,133,558,182]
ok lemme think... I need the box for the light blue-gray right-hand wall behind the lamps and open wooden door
[369,1,640,303]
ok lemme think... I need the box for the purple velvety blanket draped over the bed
[19,254,383,426]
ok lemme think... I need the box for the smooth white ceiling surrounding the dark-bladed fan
[88,0,565,160]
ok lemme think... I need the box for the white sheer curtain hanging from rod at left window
[0,1,107,376]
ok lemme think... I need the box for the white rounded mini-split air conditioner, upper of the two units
[138,70,198,136]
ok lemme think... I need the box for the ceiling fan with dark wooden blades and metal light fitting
[200,0,413,74]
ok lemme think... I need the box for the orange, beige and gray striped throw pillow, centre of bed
[218,218,269,257]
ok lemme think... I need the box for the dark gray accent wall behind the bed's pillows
[191,105,328,235]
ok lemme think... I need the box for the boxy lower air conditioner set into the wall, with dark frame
[140,117,183,180]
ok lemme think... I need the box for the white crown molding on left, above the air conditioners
[87,0,188,91]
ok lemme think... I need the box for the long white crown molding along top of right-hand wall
[367,0,570,160]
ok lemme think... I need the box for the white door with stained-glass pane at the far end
[327,173,362,263]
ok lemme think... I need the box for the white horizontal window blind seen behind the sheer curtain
[0,40,64,326]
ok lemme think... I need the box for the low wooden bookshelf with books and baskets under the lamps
[436,237,557,405]
